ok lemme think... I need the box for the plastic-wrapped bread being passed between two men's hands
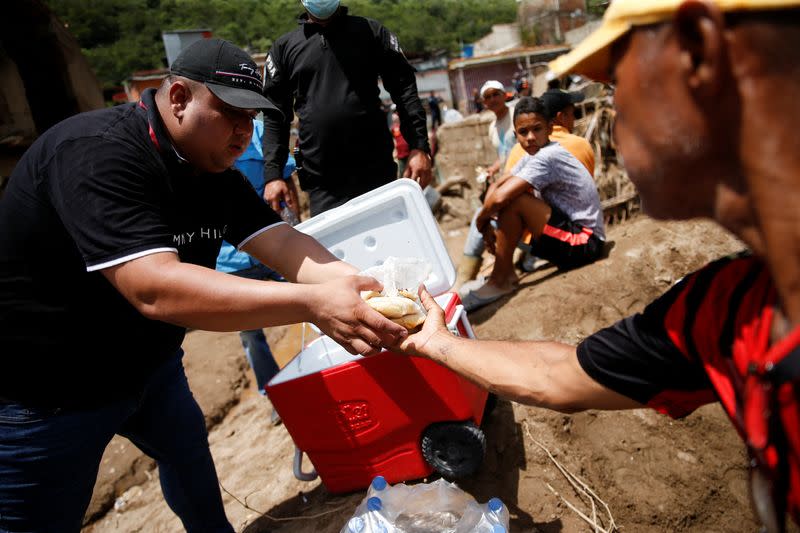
[361,257,431,330]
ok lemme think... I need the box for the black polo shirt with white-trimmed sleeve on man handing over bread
[0,90,280,407]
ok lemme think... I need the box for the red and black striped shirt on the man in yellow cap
[578,252,800,521]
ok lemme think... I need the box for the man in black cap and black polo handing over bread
[0,39,405,532]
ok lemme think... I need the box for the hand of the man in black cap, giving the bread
[310,276,408,355]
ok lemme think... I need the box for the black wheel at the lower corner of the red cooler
[422,422,486,479]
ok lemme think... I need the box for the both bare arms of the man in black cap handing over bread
[103,224,407,354]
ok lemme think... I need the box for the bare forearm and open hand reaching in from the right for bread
[399,290,642,412]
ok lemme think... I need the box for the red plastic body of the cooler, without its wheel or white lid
[267,293,487,493]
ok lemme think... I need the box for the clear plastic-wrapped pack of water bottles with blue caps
[341,476,509,533]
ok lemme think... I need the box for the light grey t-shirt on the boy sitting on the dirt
[511,141,606,241]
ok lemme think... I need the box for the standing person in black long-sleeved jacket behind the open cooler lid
[264,0,431,216]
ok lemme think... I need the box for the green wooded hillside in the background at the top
[45,0,517,87]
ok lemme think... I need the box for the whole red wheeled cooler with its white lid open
[266,179,487,492]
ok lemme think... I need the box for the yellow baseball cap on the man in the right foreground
[549,0,800,81]
